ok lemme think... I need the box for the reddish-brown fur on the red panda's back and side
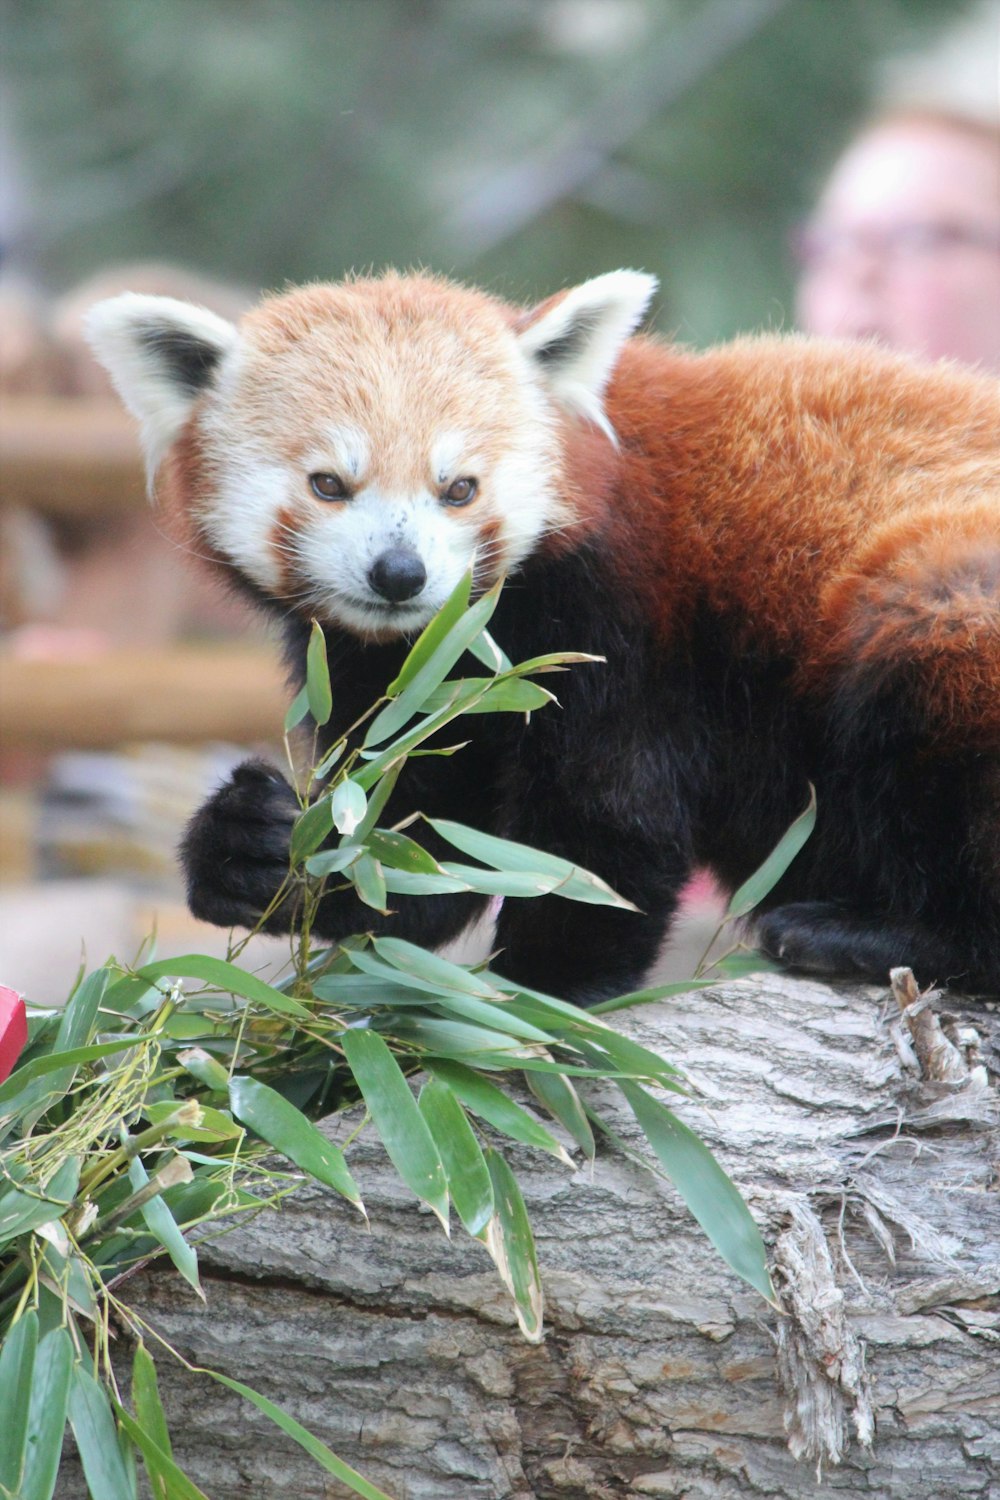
[570,339,1000,746]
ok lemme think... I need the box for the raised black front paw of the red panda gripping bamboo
[181,761,298,933]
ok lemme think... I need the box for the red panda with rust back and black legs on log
[90,270,1000,1004]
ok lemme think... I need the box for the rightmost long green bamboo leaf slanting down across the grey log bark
[618,1079,777,1305]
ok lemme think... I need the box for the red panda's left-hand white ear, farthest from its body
[84,291,237,476]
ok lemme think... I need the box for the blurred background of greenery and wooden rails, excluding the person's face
[0,0,1000,1004]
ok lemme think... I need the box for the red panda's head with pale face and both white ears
[88,272,655,639]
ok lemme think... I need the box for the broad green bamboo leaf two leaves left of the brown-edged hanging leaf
[340,1031,448,1233]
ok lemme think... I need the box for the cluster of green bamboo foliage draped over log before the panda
[0,579,811,1500]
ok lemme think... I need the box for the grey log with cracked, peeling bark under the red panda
[57,975,1000,1500]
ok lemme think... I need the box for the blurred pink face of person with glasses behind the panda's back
[798,122,1000,372]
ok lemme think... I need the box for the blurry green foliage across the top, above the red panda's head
[4,0,966,344]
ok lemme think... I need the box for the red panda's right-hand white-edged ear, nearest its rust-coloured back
[514,272,657,438]
